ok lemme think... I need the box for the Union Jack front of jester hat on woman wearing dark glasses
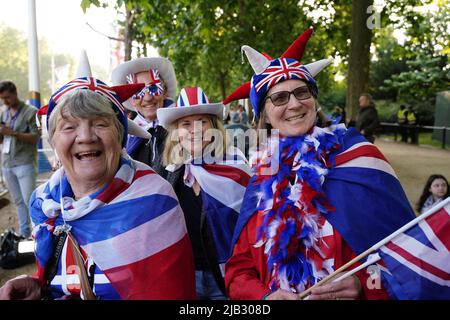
[255,58,314,92]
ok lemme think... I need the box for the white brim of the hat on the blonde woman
[157,103,224,129]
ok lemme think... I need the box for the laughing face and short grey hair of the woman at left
[48,90,124,199]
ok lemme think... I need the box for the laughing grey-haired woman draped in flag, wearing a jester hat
[0,77,195,299]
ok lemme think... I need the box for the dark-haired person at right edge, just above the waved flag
[416,174,450,213]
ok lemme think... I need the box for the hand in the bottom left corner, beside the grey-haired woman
[0,275,41,300]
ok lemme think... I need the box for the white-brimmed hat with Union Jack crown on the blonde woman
[156,87,224,129]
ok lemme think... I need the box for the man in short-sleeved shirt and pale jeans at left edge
[0,80,40,238]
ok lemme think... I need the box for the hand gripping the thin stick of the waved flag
[308,275,362,300]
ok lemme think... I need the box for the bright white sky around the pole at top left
[0,0,124,70]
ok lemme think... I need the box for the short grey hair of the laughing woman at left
[47,90,125,144]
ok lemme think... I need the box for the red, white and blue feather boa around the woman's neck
[254,125,346,292]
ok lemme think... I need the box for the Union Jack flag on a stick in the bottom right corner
[380,198,450,300]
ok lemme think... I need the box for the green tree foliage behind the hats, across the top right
[81,0,450,119]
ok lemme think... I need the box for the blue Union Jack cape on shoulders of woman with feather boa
[233,128,415,296]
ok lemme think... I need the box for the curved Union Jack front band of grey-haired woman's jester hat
[47,77,125,115]
